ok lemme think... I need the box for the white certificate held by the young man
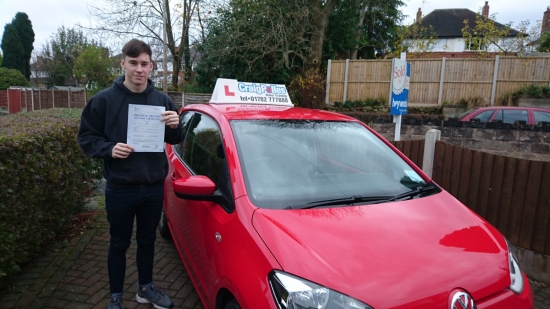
[126,104,165,152]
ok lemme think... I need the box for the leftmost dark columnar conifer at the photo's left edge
[0,23,25,76]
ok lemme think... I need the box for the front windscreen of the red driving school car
[231,120,434,209]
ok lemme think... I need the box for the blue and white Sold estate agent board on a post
[390,58,411,115]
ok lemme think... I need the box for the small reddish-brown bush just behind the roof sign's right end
[288,69,326,109]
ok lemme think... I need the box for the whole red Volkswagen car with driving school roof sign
[159,79,533,309]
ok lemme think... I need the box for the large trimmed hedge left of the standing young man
[0,108,101,277]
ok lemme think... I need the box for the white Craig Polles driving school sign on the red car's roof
[210,78,293,106]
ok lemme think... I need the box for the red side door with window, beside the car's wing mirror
[170,112,231,302]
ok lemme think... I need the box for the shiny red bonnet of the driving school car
[253,191,510,308]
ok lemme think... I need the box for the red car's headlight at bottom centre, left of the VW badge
[269,271,372,309]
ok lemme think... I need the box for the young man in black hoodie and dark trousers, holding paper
[78,39,183,309]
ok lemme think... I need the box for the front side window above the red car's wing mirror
[182,113,224,183]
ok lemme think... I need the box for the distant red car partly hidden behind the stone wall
[458,106,550,125]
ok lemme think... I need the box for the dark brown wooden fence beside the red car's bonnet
[391,140,550,255]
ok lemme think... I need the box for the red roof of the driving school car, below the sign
[184,103,357,121]
